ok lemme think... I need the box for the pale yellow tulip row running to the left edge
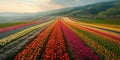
[0,21,53,46]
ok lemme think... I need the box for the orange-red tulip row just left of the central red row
[14,22,56,60]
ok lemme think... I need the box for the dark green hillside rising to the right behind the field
[45,1,120,18]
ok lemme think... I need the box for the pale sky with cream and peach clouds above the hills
[0,0,110,13]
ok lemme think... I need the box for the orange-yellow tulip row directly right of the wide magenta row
[62,23,120,60]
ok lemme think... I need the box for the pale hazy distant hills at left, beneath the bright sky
[0,12,42,23]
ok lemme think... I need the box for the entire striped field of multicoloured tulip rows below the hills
[0,16,120,60]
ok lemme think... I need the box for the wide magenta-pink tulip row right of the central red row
[61,22,101,60]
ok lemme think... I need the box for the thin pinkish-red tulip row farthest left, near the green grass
[0,22,39,33]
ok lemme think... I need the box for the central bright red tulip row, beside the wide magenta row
[42,18,70,60]
